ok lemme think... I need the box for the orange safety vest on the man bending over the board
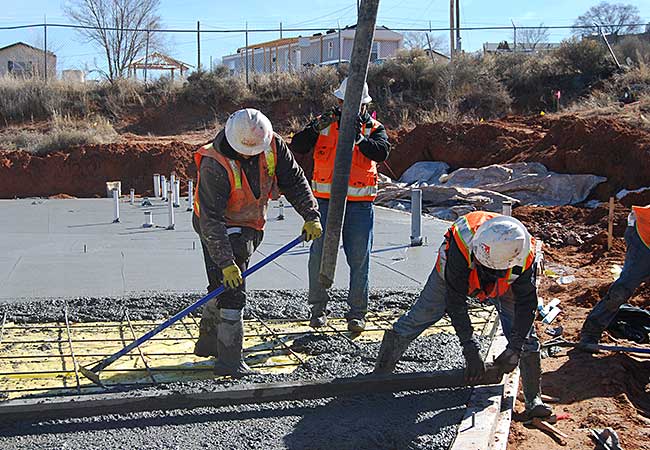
[436,211,535,301]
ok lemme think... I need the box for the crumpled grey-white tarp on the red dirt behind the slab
[376,163,606,220]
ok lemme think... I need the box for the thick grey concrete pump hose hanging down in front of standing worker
[319,0,378,288]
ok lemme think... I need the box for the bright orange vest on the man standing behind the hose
[311,118,381,202]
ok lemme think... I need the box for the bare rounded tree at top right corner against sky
[573,2,641,36]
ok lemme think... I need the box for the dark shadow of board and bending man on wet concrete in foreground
[0,391,467,442]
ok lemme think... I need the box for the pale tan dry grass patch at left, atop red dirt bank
[0,114,119,155]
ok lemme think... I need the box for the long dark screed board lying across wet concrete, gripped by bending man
[0,369,499,424]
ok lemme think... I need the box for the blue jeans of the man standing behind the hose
[309,198,375,319]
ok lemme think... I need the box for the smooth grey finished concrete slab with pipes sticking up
[0,199,448,302]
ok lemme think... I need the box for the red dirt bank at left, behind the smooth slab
[0,142,196,198]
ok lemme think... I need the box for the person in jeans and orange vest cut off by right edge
[578,205,650,352]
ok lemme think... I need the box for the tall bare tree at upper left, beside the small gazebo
[64,0,160,81]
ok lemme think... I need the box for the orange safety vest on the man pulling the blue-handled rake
[194,138,278,230]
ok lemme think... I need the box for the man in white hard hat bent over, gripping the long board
[375,211,552,417]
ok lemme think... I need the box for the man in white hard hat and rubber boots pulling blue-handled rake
[192,109,322,377]
